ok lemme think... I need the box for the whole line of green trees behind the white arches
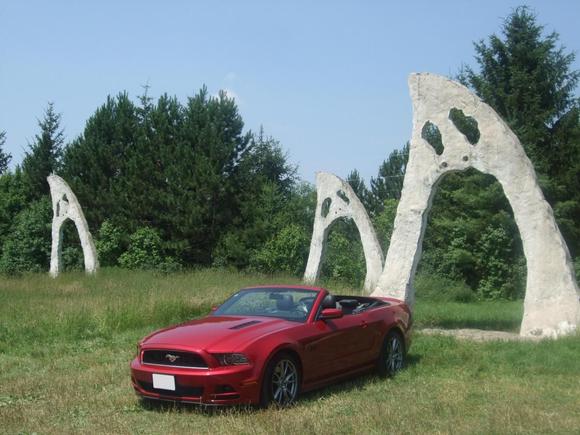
[0,7,580,299]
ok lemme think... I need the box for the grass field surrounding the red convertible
[0,270,580,434]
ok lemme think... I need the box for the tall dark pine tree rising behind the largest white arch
[460,6,580,174]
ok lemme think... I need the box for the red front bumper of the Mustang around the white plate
[131,358,260,405]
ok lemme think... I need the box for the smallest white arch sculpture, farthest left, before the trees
[47,174,99,277]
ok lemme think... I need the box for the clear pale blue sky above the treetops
[0,0,580,182]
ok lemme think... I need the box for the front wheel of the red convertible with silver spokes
[260,353,302,408]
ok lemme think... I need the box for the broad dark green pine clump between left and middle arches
[63,87,296,267]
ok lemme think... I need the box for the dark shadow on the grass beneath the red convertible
[140,354,421,416]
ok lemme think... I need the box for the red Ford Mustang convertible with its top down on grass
[131,286,411,406]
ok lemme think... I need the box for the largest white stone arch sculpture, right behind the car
[373,74,580,337]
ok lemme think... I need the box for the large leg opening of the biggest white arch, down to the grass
[414,169,526,332]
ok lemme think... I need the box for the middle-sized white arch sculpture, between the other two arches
[304,172,383,292]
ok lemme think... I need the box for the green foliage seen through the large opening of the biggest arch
[419,169,525,299]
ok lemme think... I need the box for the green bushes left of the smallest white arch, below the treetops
[0,197,52,275]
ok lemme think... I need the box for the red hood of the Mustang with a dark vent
[141,316,298,352]
